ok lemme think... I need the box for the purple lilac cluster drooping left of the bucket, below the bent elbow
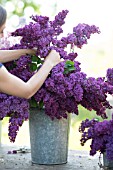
[0,93,29,142]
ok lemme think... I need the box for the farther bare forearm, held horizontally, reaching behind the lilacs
[0,49,35,63]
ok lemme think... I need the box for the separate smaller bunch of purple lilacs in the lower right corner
[79,119,113,160]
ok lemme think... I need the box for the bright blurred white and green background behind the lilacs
[0,0,113,150]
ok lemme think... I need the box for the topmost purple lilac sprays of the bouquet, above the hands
[12,10,100,60]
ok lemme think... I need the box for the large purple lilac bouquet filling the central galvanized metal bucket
[0,10,113,142]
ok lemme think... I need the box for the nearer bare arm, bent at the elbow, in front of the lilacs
[0,51,60,99]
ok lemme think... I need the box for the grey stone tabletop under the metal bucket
[0,146,102,170]
